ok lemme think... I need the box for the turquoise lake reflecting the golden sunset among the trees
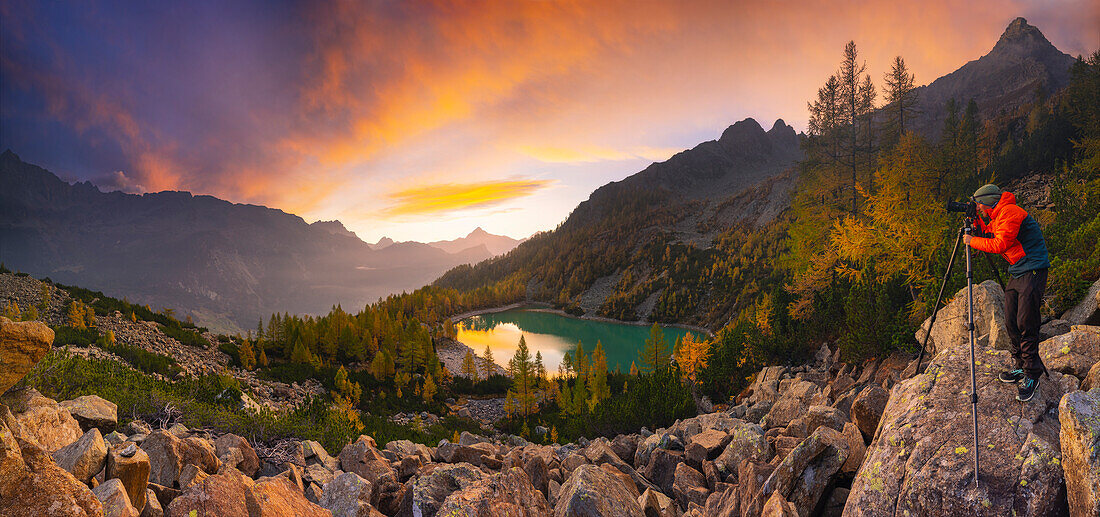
[458,308,704,375]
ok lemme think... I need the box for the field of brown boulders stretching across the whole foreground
[0,278,1100,517]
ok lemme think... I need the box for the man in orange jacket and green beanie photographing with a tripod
[963,185,1051,402]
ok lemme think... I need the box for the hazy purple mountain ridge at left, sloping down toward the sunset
[0,151,493,331]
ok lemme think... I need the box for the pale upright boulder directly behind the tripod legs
[916,281,1012,354]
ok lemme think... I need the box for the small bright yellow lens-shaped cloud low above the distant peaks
[382,179,554,218]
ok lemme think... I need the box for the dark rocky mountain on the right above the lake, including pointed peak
[437,18,1075,325]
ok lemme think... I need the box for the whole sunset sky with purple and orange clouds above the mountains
[0,0,1100,242]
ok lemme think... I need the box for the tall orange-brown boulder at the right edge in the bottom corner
[1058,389,1100,517]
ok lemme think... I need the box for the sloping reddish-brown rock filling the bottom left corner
[0,404,103,517]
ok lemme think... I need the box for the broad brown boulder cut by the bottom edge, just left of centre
[437,466,551,517]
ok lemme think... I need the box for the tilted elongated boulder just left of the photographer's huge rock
[741,426,848,515]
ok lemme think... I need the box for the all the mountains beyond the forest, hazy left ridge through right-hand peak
[0,19,1074,330]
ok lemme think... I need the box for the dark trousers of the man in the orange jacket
[1004,268,1046,378]
